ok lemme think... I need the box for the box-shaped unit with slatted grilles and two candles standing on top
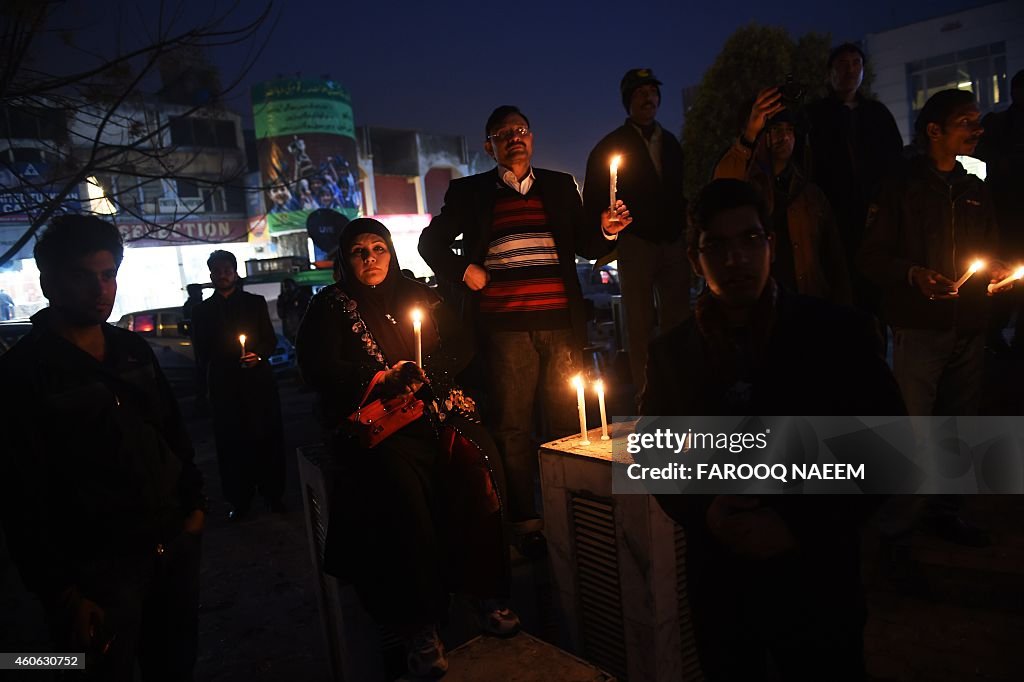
[540,424,703,682]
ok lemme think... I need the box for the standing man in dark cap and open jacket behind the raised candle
[583,69,690,393]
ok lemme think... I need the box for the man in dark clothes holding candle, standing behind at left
[193,251,285,521]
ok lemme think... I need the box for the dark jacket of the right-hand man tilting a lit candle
[860,157,999,334]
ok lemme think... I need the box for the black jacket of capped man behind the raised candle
[583,122,686,242]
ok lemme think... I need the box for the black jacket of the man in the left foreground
[0,310,206,598]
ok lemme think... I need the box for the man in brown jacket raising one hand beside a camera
[715,87,850,305]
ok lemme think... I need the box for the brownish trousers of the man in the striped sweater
[486,329,579,532]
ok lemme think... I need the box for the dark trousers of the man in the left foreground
[47,532,202,682]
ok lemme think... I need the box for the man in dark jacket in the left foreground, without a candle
[0,215,206,680]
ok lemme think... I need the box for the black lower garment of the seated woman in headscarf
[324,417,509,632]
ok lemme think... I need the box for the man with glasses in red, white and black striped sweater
[419,105,632,558]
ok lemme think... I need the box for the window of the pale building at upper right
[906,43,1010,121]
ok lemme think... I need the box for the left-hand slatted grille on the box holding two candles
[569,495,628,681]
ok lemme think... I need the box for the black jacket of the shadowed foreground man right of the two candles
[640,290,906,636]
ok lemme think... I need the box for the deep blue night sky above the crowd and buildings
[79,0,985,179]
